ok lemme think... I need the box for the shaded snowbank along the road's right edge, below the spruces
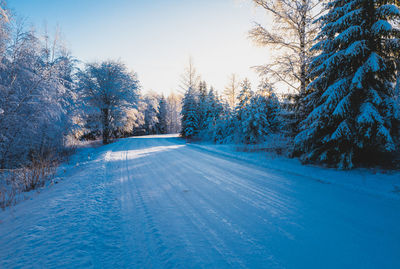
[190,140,400,199]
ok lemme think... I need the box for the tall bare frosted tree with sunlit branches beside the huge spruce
[250,0,325,124]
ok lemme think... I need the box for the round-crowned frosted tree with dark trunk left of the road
[78,61,140,144]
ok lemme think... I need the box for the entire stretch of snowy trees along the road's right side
[181,0,400,169]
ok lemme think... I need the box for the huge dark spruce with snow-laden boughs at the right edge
[295,0,400,169]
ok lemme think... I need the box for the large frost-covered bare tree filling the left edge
[0,21,74,168]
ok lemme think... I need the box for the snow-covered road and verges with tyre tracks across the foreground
[0,136,400,268]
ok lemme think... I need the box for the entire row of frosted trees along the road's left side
[0,1,180,171]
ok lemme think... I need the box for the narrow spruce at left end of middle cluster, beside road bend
[181,87,199,138]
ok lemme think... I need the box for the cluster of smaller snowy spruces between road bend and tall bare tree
[181,79,282,144]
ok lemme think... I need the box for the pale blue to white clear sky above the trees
[7,0,269,94]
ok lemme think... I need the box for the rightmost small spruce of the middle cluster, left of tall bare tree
[243,83,280,144]
